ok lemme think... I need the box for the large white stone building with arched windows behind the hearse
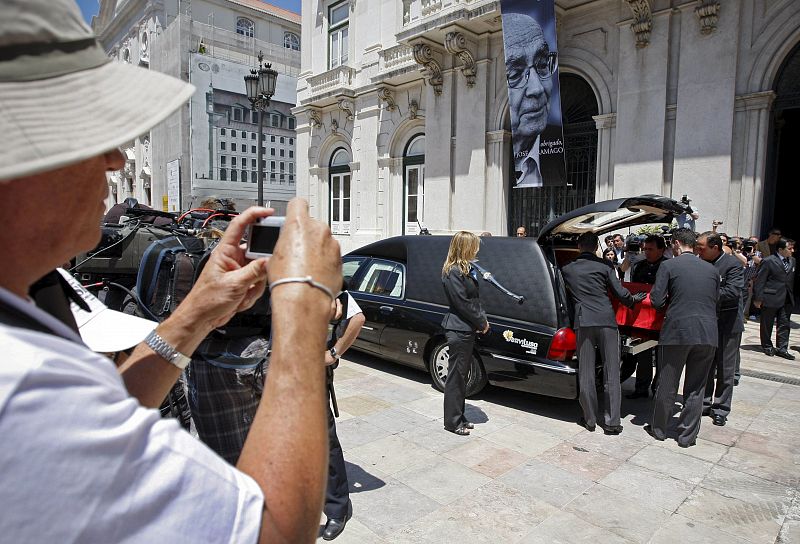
[294,0,800,250]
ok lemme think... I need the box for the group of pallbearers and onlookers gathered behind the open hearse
[564,218,795,447]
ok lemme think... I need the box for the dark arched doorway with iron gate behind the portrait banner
[507,73,598,236]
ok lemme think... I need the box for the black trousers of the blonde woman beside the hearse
[444,330,475,431]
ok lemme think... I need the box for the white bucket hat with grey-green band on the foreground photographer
[0,0,194,181]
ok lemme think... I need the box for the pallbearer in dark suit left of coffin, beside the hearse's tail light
[562,232,645,434]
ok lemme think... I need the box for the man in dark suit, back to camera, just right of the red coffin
[644,229,719,448]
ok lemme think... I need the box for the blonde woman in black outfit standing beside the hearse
[442,231,489,436]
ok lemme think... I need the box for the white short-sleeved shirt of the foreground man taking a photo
[0,289,264,543]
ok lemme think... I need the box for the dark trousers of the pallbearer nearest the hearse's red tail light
[577,327,622,426]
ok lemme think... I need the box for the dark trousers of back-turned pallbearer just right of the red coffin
[651,345,716,445]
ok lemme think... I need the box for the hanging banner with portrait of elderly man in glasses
[500,0,567,189]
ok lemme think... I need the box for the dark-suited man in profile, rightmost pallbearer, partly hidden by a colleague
[696,232,744,426]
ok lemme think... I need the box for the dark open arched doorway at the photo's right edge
[764,39,800,306]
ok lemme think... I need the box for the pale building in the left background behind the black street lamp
[92,0,300,211]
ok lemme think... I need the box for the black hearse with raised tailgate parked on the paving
[343,195,683,398]
